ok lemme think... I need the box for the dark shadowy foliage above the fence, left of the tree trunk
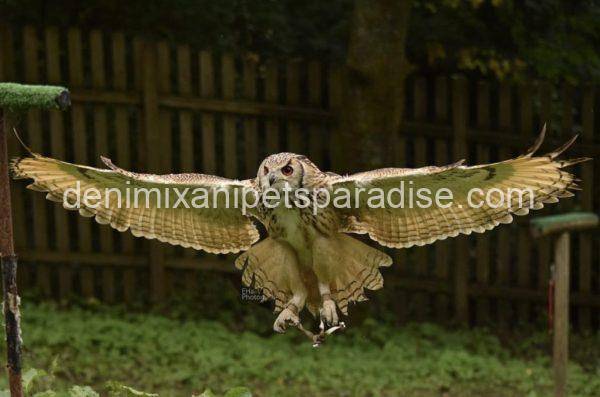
[0,0,352,60]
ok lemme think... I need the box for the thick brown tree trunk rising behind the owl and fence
[340,0,411,169]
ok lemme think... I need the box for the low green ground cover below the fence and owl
[0,304,600,397]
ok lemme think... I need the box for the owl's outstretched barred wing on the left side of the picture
[11,154,259,253]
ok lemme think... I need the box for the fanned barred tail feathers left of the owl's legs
[235,238,296,312]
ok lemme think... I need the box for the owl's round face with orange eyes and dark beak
[257,153,304,190]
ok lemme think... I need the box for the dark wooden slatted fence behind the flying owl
[0,27,600,330]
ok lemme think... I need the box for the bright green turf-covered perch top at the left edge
[0,83,71,111]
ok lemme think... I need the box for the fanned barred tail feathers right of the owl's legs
[315,234,392,314]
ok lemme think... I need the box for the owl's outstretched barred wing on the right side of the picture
[330,131,589,248]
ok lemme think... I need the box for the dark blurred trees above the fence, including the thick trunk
[5,0,600,167]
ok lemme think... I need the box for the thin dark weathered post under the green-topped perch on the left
[0,110,23,397]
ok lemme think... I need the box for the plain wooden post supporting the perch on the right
[553,232,570,397]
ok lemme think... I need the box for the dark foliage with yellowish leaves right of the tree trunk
[408,0,600,82]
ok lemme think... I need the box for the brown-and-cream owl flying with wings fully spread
[11,131,587,332]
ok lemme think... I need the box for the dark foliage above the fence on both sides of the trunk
[0,0,600,82]
